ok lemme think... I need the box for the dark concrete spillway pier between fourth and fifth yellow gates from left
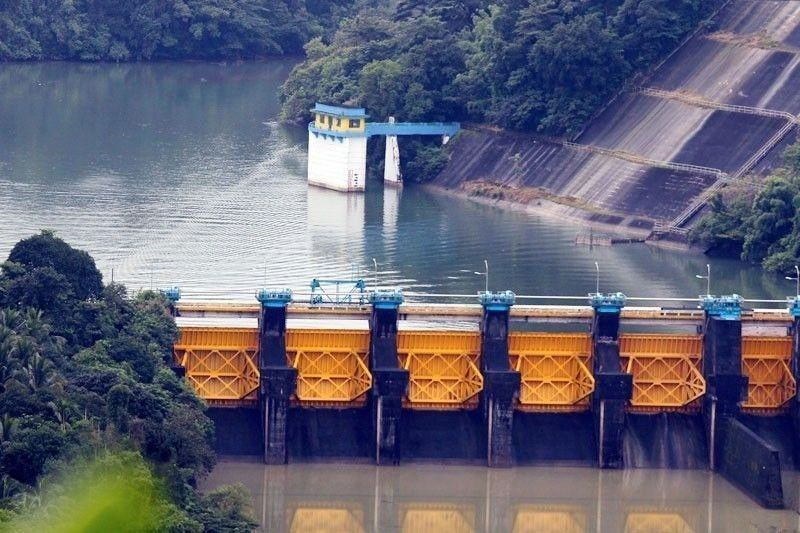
[589,292,633,468]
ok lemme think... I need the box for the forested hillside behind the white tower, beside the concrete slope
[283,0,722,134]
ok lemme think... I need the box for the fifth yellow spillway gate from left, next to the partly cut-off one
[619,333,706,412]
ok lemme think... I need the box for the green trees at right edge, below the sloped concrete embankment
[690,141,800,272]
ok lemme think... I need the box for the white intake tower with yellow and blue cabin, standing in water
[308,104,367,191]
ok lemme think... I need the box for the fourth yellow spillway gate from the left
[508,332,594,411]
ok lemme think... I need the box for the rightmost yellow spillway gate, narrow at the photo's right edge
[742,336,797,412]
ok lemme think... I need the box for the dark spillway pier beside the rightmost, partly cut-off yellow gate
[701,294,748,470]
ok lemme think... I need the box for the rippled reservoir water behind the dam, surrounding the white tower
[0,61,794,300]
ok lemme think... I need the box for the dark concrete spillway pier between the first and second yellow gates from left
[256,289,297,464]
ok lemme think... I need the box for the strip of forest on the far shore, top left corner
[0,0,356,61]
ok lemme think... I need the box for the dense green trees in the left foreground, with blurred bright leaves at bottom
[0,232,253,531]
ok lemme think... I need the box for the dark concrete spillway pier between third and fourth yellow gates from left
[479,291,520,467]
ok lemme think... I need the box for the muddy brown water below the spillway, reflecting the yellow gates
[206,459,799,533]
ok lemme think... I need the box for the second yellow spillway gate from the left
[286,329,372,407]
